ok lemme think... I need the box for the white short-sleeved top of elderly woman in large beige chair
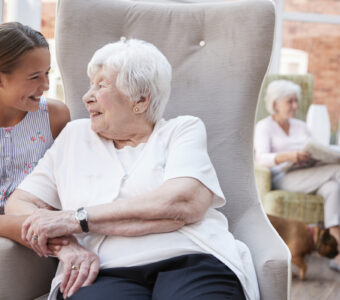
[19,116,259,300]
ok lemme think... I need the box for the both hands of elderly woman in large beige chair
[21,209,100,299]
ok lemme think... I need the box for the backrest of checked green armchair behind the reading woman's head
[256,74,314,122]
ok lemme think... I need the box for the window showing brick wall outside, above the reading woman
[271,0,340,140]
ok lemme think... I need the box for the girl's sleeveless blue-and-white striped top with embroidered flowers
[0,97,53,213]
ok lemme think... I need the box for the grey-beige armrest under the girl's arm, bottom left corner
[0,237,57,300]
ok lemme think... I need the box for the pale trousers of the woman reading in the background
[273,164,340,228]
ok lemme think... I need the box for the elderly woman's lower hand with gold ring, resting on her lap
[50,237,100,298]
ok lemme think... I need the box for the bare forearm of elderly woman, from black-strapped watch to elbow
[87,178,213,234]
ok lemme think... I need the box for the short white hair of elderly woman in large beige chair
[87,39,172,122]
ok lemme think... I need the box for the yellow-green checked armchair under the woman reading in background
[255,74,323,224]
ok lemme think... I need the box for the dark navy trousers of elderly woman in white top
[57,254,245,300]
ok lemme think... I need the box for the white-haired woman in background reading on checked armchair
[254,80,340,271]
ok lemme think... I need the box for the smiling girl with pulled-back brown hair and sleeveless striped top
[0,22,70,243]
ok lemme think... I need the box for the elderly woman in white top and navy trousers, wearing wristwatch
[6,40,259,300]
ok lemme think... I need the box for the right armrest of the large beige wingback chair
[237,204,291,300]
